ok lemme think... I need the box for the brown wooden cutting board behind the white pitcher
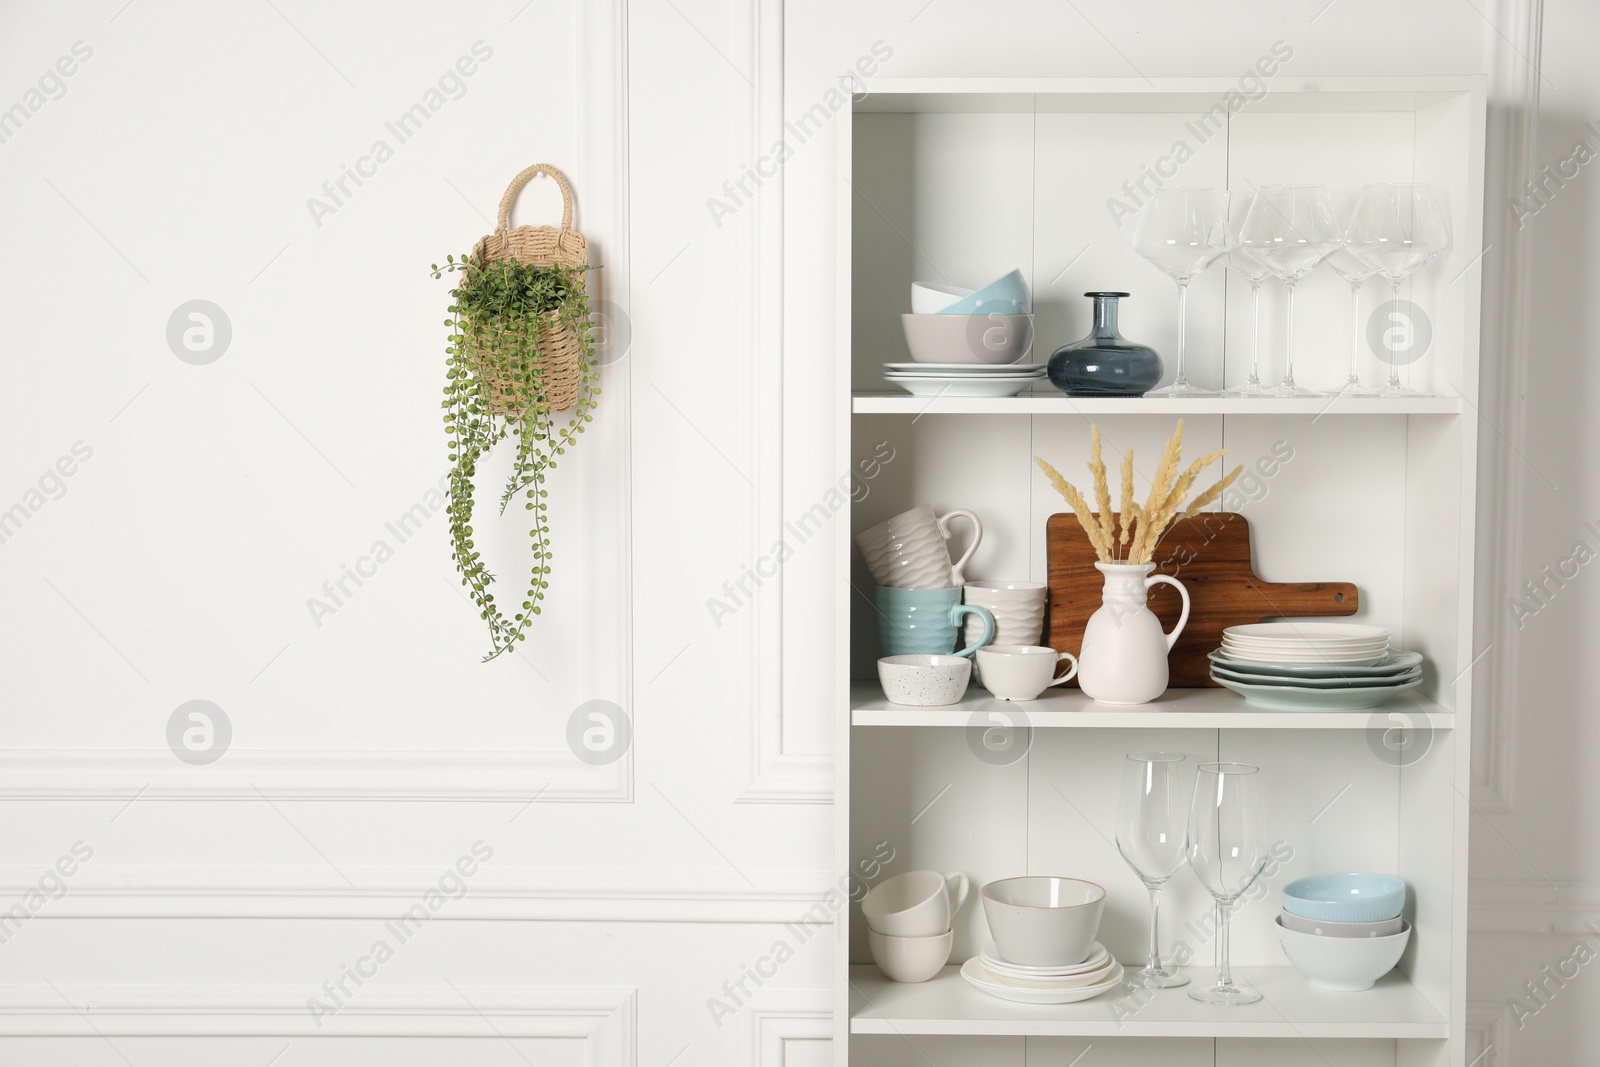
[1045,512,1360,688]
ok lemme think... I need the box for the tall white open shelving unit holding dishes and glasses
[834,77,1485,1067]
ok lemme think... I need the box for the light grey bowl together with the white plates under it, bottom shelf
[962,877,1123,1005]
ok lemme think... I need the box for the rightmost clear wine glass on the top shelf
[1346,184,1450,397]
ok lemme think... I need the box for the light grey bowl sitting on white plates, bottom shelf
[982,875,1106,966]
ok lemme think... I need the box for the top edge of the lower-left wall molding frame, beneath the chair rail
[0,985,638,1049]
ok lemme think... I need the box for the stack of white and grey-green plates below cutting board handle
[1210,622,1422,712]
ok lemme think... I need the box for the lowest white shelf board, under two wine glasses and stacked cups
[850,965,1450,1040]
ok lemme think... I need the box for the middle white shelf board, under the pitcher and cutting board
[850,681,1456,729]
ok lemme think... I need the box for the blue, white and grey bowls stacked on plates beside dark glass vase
[883,270,1045,397]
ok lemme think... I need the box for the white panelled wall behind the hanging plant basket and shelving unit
[0,0,1600,1067]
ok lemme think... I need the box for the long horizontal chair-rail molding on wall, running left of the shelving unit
[0,864,827,933]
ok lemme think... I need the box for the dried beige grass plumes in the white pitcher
[1034,419,1245,565]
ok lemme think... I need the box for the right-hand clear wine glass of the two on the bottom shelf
[1186,763,1267,1005]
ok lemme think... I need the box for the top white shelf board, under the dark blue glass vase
[850,395,1462,418]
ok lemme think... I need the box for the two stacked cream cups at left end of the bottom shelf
[861,870,970,982]
